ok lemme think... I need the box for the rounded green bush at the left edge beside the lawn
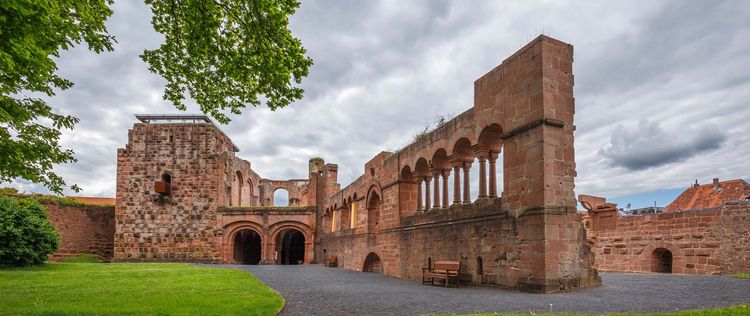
[0,197,60,268]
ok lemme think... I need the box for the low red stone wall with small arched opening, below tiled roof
[588,202,750,274]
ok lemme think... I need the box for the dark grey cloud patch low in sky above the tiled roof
[599,121,727,170]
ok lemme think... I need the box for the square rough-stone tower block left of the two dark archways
[114,123,232,262]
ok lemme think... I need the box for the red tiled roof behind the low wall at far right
[664,179,750,212]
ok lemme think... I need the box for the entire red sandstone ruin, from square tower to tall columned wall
[114,36,601,292]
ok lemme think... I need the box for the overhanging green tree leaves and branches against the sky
[0,0,312,194]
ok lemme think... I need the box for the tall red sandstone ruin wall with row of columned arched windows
[317,36,600,292]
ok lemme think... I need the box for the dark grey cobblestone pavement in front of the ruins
[206,265,750,315]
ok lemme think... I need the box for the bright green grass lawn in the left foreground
[0,262,284,315]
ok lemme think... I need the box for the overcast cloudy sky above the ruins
[7,0,750,207]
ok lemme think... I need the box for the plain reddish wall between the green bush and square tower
[44,204,115,261]
